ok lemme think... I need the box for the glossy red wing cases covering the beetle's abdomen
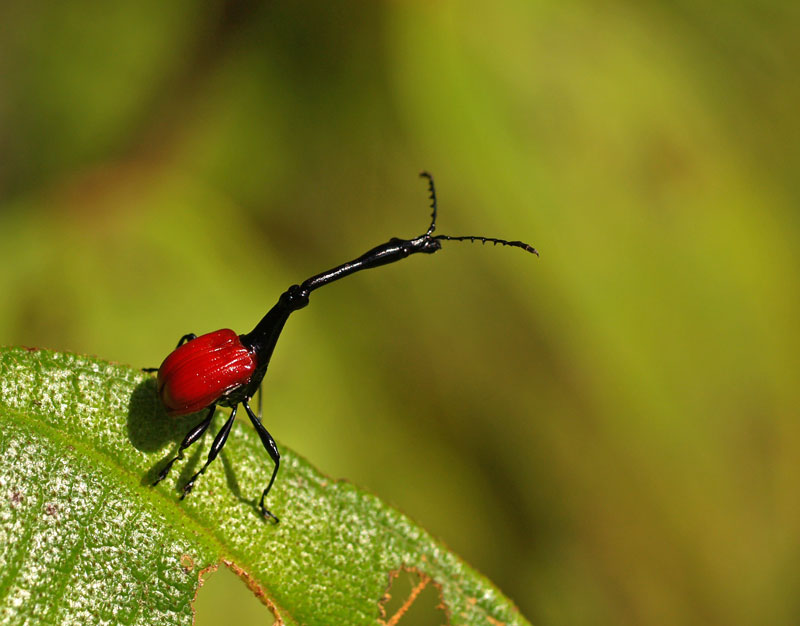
[158,328,256,415]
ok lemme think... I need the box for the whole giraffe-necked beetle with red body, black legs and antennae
[146,172,539,523]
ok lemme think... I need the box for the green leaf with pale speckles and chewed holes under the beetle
[0,348,528,625]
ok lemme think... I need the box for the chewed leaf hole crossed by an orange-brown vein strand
[379,567,449,626]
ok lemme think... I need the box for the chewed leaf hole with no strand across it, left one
[194,567,281,626]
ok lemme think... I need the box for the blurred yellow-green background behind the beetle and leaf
[0,0,800,626]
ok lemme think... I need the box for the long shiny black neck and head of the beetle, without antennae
[241,234,442,368]
